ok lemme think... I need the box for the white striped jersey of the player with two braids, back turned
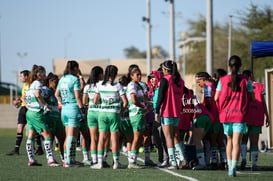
[95,81,125,113]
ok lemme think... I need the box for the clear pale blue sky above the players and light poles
[0,0,273,83]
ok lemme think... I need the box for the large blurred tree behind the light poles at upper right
[183,4,273,79]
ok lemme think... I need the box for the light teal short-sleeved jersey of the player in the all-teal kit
[57,74,81,105]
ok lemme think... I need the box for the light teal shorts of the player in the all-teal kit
[61,104,82,127]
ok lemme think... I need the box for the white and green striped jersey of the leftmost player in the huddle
[25,80,44,112]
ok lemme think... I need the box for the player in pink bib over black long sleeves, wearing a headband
[155,60,184,169]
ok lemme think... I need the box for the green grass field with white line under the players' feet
[0,129,273,181]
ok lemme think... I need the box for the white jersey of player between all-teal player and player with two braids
[83,81,102,111]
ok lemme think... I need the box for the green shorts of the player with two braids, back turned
[99,112,120,132]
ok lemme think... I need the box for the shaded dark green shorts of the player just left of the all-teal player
[45,112,64,134]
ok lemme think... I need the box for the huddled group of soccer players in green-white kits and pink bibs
[6,55,270,176]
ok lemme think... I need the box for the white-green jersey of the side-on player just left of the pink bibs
[126,81,145,116]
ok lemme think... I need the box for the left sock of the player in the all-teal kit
[66,136,77,165]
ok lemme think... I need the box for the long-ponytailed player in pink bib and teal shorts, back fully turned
[215,55,255,177]
